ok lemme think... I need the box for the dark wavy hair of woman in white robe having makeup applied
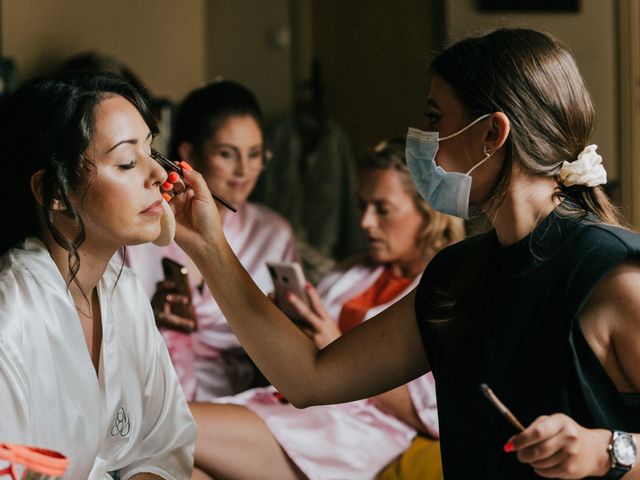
[0,72,158,284]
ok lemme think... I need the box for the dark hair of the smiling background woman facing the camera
[169,80,263,161]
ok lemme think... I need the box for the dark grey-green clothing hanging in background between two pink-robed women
[251,114,364,284]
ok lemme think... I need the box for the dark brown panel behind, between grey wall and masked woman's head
[313,0,444,152]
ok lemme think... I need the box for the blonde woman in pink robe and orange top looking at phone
[191,142,463,479]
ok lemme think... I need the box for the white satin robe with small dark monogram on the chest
[0,238,195,480]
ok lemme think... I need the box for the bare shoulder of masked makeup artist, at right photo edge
[580,259,640,392]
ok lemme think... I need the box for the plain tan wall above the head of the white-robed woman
[0,0,206,100]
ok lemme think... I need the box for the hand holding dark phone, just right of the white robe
[151,257,197,333]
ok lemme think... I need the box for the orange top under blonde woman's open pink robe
[338,269,413,333]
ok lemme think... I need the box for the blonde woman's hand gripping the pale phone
[286,283,342,348]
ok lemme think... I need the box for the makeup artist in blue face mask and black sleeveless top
[174,29,640,480]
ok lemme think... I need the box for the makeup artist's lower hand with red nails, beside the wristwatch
[505,413,611,478]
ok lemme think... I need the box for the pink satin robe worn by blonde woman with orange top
[216,264,438,480]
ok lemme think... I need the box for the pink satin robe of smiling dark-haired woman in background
[126,203,297,401]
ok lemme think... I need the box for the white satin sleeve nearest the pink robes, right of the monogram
[120,307,196,480]
